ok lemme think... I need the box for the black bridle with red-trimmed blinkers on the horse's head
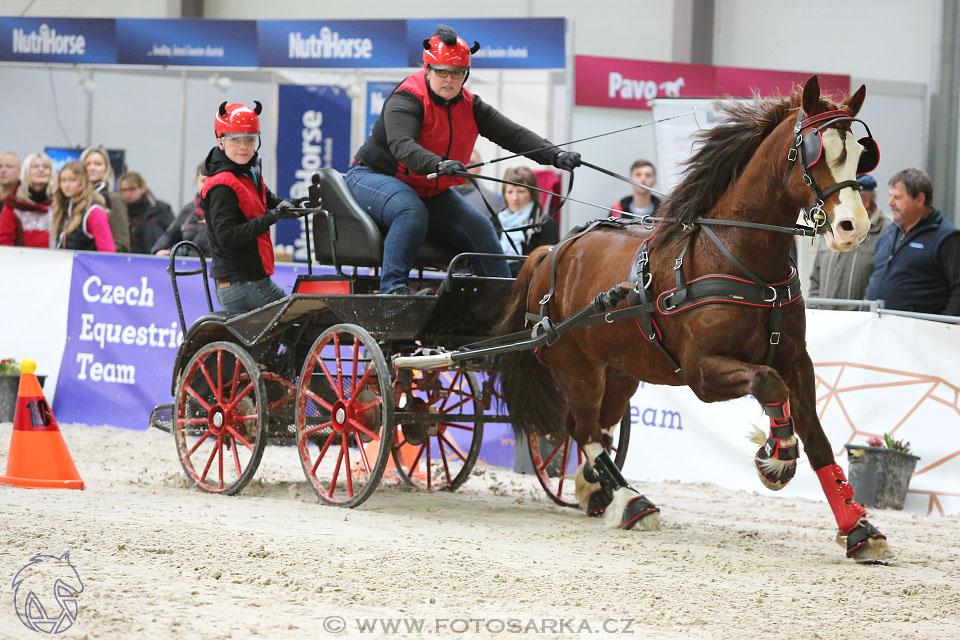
[783,109,880,231]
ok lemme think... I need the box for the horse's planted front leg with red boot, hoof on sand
[790,353,892,562]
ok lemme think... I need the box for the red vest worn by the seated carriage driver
[396,71,480,198]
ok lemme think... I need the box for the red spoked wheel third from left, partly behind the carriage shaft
[393,370,483,491]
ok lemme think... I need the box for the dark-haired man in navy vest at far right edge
[864,169,960,316]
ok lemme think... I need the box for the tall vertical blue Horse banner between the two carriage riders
[276,85,352,262]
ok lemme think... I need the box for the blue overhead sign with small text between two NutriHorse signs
[117,18,257,67]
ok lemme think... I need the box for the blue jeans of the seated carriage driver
[347,165,510,293]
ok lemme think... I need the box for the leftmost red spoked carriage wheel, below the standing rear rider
[173,342,267,495]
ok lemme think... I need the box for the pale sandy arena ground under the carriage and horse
[0,424,960,640]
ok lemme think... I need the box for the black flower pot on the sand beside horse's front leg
[843,444,920,509]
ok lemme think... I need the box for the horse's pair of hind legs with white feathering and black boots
[554,366,660,530]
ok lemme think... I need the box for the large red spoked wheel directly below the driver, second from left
[297,324,393,507]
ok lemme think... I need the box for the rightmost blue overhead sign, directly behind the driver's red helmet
[407,18,567,69]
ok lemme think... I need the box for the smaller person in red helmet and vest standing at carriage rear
[200,102,297,313]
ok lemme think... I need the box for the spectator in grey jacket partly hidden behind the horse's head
[810,174,893,309]
